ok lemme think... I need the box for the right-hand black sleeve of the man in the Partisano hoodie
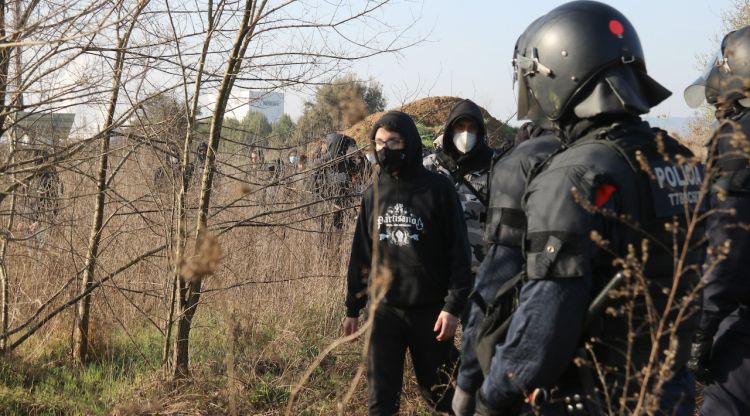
[443,180,471,316]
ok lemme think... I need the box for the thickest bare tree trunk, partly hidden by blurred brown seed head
[174,0,266,379]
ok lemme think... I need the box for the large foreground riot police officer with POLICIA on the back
[476,1,703,415]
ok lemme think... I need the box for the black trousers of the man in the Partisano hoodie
[367,305,458,416]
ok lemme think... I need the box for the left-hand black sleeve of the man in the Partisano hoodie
[346,193,372,318]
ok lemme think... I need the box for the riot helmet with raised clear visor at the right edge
[685,26,750,108]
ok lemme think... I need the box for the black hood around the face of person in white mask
[442,99,492,172]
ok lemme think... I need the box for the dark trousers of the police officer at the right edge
[701,329,750,416]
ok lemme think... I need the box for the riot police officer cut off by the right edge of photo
[685,26,750,415]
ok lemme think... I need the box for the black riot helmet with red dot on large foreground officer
[513,1,671,123]
